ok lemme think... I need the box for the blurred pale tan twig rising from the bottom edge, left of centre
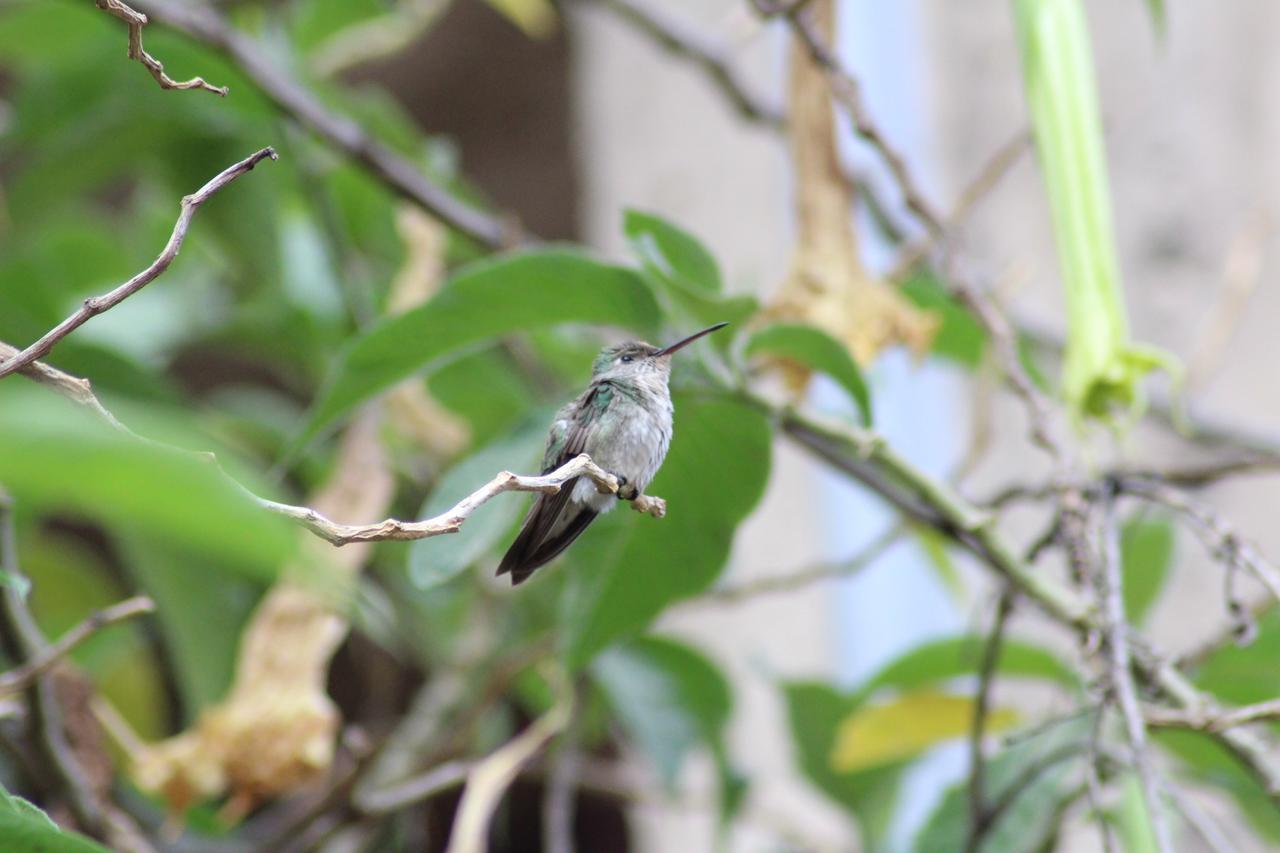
[447,686,573,853]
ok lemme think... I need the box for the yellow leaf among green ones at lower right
[831,690,1018,774]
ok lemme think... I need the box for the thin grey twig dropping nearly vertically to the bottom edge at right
[1097,496,1174,853]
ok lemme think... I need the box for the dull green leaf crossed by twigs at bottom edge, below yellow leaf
[914,721,1087,853]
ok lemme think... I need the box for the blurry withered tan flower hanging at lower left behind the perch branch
[133,412,394,817]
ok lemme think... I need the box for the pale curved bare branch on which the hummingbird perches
[259,453,667,546]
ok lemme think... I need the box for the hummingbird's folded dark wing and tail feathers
[498,382,613,585]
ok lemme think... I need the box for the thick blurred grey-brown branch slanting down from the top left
[124,0,514,248]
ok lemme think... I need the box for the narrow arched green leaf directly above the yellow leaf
[854,634,1079,702]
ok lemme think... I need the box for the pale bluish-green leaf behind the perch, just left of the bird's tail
[408,412,549,589]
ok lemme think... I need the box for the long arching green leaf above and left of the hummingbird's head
[294,248,659,450]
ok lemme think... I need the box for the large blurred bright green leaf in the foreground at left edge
[0,380,297,576]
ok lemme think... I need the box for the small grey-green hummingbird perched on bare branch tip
[498,323,728,585]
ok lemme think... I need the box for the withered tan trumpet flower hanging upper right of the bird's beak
[765,0,937,371]
